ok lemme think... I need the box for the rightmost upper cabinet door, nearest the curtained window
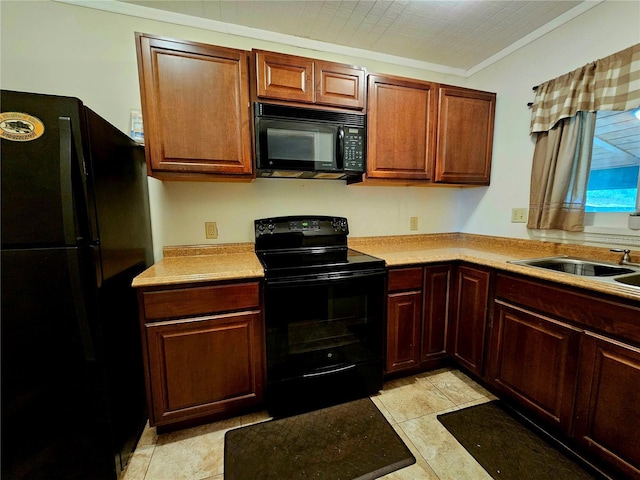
[434,86,496,185]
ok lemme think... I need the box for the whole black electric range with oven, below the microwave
[255,216,386,417]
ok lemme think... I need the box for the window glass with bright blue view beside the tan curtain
[586,108,640,212]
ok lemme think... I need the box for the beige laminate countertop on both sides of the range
[133,233,640,301]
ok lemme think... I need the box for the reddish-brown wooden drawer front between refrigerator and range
[142,282,260,321]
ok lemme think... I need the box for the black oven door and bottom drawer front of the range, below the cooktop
[264,270,385,415]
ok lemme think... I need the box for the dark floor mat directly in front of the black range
[224,398,416,480]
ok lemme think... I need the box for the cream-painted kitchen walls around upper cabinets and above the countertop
[0,1,640,258]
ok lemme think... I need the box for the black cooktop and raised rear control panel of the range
[254,216,384,278]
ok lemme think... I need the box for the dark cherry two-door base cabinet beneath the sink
[496,272,640,479]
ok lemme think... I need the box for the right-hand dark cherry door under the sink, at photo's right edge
[574,333,640,478]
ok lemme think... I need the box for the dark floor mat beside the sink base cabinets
[438,401,601,480]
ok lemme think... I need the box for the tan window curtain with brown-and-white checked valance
[527,44,640,232]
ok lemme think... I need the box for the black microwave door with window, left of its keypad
[255,117,344,172]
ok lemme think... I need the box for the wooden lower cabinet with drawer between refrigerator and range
[139,282,265,427]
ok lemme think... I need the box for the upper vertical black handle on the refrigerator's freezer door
[58,117,76,245]
